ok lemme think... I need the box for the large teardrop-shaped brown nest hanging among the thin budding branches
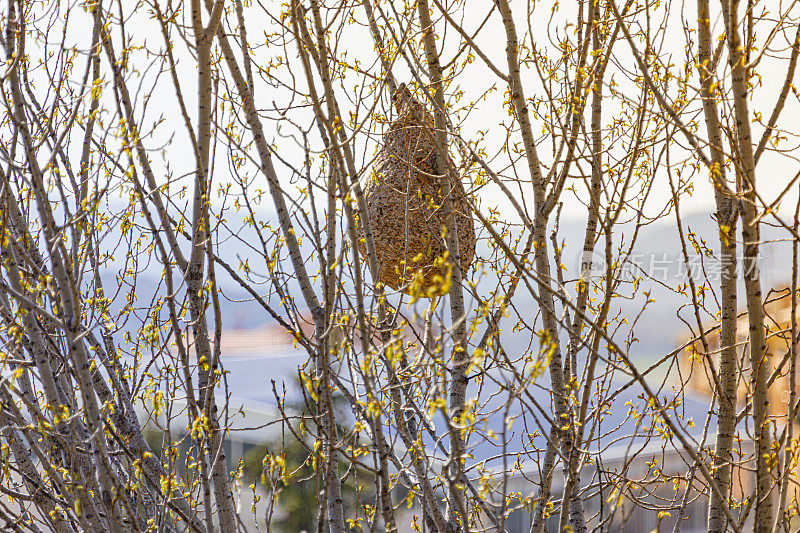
[359,84,475,297]
